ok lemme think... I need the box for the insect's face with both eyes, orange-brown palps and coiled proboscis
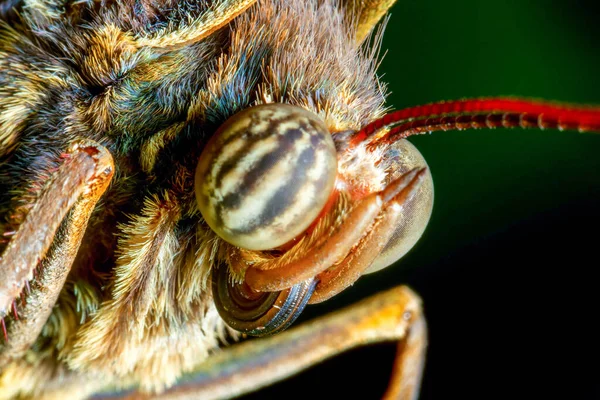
[195,103,433,334]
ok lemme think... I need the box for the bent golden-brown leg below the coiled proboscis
[99,287,426,400]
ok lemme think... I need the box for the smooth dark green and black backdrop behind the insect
[247,0,600,399]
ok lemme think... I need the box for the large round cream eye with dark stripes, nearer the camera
[195,104,337,250]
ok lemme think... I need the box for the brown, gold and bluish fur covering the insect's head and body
[0,0,392,398]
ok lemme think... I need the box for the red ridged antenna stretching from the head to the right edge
[349,97,600,148]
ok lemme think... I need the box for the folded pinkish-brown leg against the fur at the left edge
[0,141,114,365]
